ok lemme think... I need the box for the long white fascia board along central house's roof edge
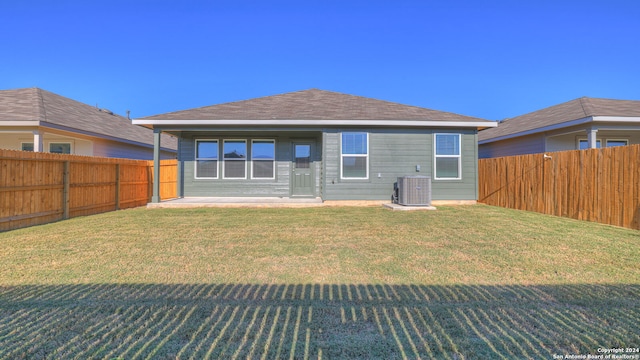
[132,119,498,128]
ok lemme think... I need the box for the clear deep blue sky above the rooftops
[0,0,640,120]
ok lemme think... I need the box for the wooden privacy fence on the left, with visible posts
[0,150,177,231]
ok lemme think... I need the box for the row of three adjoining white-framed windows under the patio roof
[195,139,276,179]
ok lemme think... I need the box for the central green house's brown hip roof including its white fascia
[134,89,493,127]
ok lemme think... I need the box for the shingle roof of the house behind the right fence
[478,97,640,143]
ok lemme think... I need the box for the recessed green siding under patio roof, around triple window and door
[179,132,322,197]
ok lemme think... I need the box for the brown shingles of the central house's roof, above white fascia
[141,89,487,122]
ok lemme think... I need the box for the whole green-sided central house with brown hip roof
[133,89,497,202]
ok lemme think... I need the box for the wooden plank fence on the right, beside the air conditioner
[478,145,640,229]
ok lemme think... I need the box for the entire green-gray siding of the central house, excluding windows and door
[172,128,477,200]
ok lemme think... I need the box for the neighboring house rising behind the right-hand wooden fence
[478,97,640,158]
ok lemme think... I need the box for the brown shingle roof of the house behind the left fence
[0,88,177,150]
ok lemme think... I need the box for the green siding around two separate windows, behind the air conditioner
[322,129,478,200]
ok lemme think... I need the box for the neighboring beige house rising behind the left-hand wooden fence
[0,88,177,160]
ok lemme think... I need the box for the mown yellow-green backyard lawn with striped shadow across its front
[0,205,640,359]
